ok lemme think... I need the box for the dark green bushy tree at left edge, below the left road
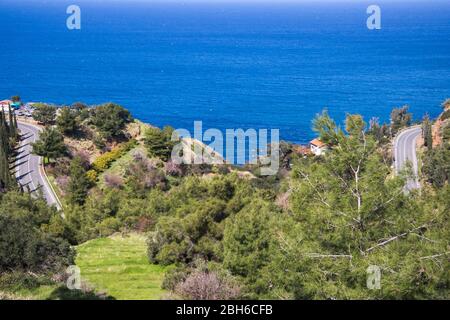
[0,191,74,274]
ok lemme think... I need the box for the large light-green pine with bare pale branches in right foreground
[259,113,448,299]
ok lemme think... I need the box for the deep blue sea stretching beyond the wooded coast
[0,0,450,143]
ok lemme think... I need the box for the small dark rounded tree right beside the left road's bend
[32,127,67,160]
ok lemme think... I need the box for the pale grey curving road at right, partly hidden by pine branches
[394,127,422,190]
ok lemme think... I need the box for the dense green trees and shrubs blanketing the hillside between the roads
[0,103,450,299]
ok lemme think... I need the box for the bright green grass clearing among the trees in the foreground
[76,234,166,300]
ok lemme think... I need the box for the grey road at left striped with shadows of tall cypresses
[14,122,61,210]
